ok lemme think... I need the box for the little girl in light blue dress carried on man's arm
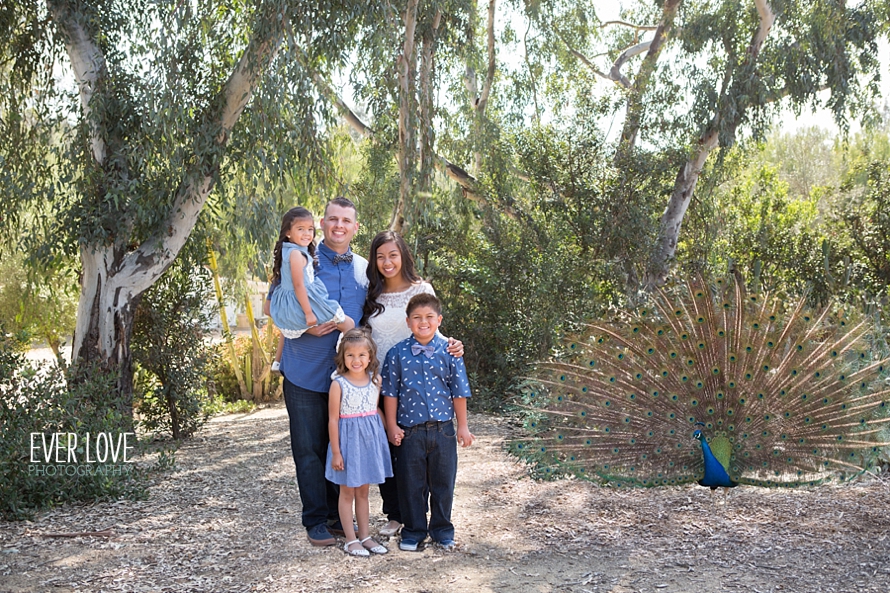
[269,206,355,338]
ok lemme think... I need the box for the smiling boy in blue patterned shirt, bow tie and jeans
[381,293,475,552]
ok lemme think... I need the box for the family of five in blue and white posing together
[266,197,475,556]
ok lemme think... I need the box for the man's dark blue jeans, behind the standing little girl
[282,378,340,529]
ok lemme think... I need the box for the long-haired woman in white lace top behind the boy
[362,231,464,536]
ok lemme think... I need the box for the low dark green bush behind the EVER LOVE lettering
[0,336,148,519]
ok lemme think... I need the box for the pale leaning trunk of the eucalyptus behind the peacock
[645,0,776,290]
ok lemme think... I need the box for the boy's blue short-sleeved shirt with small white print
[381,335,470,428]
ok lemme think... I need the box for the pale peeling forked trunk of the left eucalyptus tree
[49,0,284,405]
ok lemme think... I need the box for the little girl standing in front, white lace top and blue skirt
[325,329,392,556]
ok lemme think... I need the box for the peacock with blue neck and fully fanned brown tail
[512,276,890,489]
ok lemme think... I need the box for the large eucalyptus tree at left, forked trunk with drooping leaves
[0,0,376,400]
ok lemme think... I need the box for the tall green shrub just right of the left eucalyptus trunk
[132,247,213,439]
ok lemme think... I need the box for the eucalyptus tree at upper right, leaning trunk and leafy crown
[525,0,887,287]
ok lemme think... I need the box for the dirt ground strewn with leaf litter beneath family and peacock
[0,406,890,593]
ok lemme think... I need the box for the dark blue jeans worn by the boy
[396,421,457,542]
